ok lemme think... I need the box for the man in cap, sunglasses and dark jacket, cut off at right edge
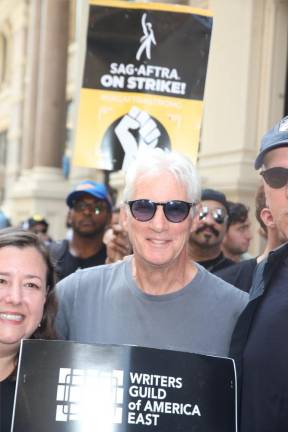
[231,116,288,432]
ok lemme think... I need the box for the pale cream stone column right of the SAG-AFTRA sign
[199,0,288,253]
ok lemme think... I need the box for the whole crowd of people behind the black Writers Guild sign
[0,117,288,432]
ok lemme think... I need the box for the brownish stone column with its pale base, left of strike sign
[10,0,69,239]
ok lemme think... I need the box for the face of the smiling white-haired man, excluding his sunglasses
[121,172,192,268]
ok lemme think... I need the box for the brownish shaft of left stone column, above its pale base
[34,0,69,167]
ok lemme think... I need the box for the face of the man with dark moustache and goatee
[190,200,227,253]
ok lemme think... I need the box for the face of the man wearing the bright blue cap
[69,194,111,237]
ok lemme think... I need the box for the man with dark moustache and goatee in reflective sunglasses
[189,189,234,273]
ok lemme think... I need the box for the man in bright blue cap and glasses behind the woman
[50,180,112,279]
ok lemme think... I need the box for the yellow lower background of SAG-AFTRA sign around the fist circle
[74,89,203,169]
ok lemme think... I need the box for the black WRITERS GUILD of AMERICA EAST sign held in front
[12,340,237,432]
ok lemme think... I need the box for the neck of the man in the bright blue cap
[69,232,103,258]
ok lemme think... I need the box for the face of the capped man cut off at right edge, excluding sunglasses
[263,146,288,240]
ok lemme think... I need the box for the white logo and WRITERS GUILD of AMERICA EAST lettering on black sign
[55,368,201,426]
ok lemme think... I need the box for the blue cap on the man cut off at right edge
[254,116,288,169]
